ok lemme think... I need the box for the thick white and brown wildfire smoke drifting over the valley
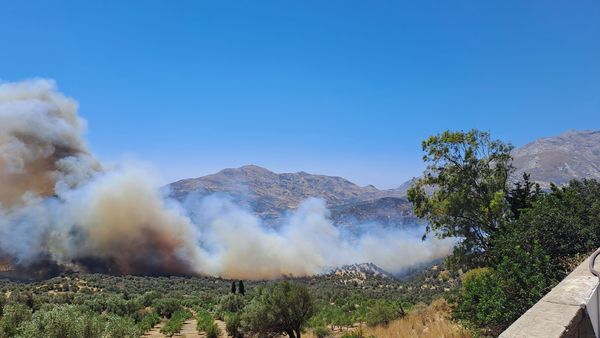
[0,80,452,279]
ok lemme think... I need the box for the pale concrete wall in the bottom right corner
[500,257,600,338]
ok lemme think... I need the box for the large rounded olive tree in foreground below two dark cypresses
[242,281,315,338]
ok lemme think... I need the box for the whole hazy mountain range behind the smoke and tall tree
[169,131,600,226]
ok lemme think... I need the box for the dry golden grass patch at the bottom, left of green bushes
[303,299,471,338]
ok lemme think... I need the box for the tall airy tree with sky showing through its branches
[408,130,513,267]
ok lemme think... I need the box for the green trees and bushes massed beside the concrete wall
[408,130,600,336]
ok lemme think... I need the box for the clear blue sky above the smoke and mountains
[0,0,600,188]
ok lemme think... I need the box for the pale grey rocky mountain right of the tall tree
[513,130,600,188]
